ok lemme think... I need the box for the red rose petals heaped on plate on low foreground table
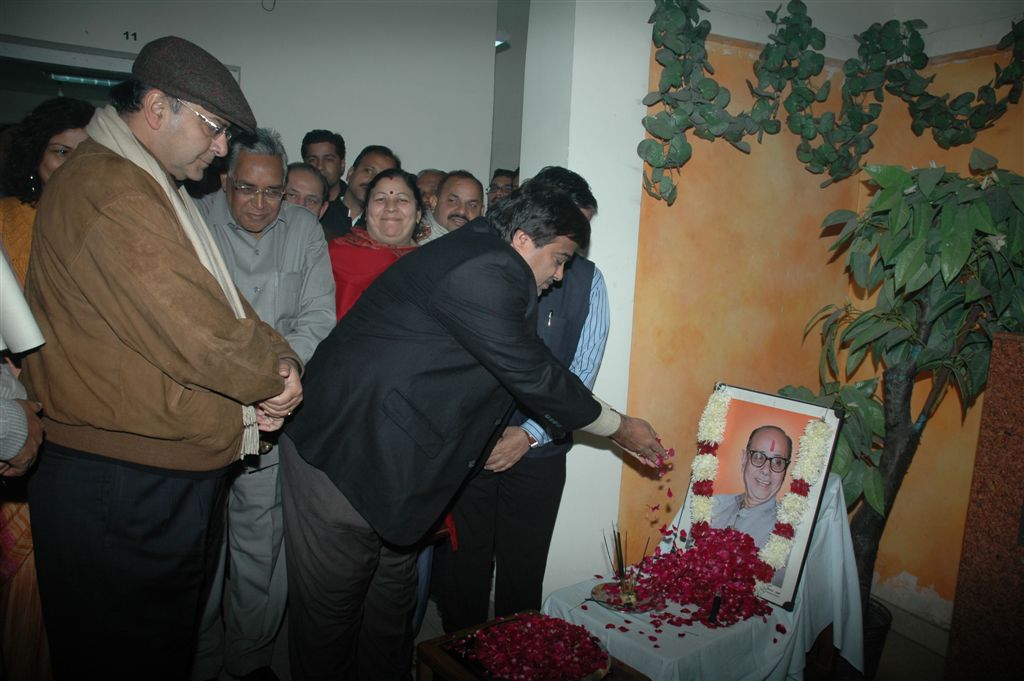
[454,613,608,681]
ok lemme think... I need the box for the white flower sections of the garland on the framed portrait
[690,385,834,595]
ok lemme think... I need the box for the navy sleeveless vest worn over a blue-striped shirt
[509,256,594,458]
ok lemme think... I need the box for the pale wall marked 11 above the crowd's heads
[0,0,497,178]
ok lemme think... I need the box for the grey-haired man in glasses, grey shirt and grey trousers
[193,128,335,681]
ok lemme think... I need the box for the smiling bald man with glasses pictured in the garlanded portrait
[711,425,793,547]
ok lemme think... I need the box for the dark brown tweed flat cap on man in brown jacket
[131,36,256,132]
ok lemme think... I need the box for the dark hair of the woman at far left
[3,97,95,204]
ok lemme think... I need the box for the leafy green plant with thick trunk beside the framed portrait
[780,150,1024,612]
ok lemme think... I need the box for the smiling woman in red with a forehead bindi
[328,168,423,320]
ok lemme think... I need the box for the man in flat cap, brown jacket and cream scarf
[23,37,302,681]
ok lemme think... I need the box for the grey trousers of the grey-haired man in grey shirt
[191,448,288,681]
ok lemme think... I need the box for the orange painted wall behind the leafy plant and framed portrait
[620,35,1024,600]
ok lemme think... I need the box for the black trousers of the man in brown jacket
[29,444,226,681]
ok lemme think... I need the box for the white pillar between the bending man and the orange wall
[522,0,656,593]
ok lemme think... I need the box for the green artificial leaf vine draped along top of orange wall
[637,0,1024,205]
